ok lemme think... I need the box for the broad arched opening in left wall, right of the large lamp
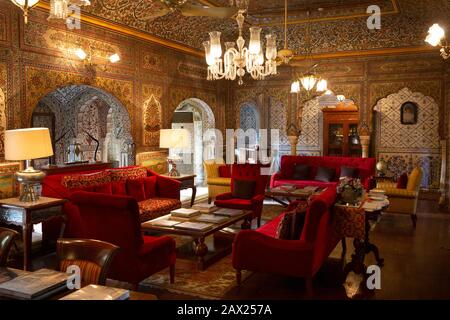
[31,85,134,167]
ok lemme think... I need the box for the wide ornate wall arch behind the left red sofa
[31,85,134,164]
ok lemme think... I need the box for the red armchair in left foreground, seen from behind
[71,192,176,289]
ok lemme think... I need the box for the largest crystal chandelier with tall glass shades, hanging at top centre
[203,9,277,85]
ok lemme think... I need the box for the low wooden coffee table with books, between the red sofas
[141,210,252,270]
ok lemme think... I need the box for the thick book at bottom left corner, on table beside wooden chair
[0,269,69,300]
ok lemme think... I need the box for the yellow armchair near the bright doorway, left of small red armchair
[203,159,231,203]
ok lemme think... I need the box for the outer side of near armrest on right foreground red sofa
[233,230,314,272]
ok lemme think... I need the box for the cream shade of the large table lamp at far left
[5,128,53,161]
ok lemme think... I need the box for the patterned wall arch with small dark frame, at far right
[373,88,441,189]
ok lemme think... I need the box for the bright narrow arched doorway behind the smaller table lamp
[169,98,215,181]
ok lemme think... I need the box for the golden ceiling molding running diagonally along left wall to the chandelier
[36,1,205,57]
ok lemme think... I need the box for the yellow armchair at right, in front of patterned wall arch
[377,167,423,228]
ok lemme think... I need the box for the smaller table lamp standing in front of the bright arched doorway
[159,129,190,177]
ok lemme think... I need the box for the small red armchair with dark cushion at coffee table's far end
[214,164,269,227]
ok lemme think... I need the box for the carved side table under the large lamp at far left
[0,197,66,271]
